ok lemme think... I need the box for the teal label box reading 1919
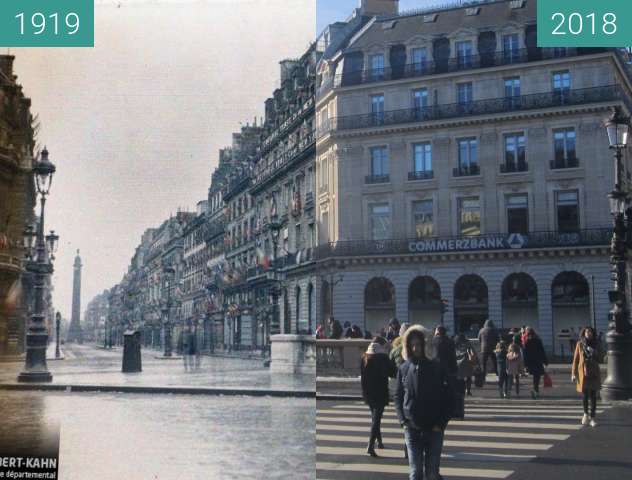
[0,0,94,47]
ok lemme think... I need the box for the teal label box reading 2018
[537,0,632,47]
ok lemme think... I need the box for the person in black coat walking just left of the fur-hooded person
[360,337,396,457]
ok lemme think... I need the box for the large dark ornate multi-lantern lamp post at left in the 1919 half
[18,148,59,382]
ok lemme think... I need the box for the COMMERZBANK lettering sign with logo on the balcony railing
[408,233,528,253]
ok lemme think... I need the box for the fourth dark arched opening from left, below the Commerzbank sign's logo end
[502,273,538,331]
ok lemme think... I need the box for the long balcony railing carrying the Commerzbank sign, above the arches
[314,227,612,260]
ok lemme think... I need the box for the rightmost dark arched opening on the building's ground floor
[552,272,591,356]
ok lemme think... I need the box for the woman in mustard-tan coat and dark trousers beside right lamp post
[571,327,601,427]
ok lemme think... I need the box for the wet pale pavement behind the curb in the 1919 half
[0,344,315,397]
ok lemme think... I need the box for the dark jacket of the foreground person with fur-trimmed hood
[395,359,455,429]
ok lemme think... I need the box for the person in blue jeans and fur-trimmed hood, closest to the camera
[395,325,454,480]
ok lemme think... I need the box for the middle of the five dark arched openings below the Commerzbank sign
[454,275,489,336]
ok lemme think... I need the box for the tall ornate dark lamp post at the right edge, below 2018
[601,107,632,400]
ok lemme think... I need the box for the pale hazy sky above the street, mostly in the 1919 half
[9,0,444,318]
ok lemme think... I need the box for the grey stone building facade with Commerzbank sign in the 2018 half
[315,0,632,353]
